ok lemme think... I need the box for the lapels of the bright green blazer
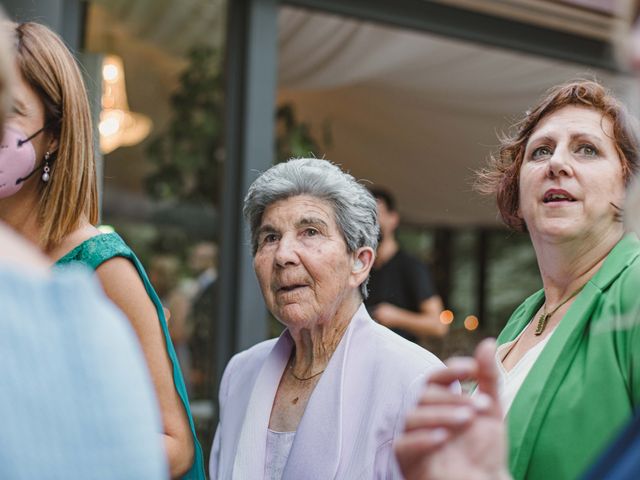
[508,235,639,478]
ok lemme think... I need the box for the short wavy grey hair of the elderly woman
[243,158,380,298]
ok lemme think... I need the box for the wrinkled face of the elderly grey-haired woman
[253,195,359,328]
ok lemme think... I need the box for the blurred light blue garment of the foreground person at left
[0,267,168,480]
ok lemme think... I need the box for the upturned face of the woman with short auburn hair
[518,106,625,240]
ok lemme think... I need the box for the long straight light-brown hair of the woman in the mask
[9,22,98,249]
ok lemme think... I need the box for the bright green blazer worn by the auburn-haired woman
[498,234,640,480]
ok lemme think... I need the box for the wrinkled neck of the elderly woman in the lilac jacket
[289,292,362,378]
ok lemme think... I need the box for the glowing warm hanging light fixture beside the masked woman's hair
[98,55,152,154]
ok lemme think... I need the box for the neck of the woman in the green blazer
[531,228,624,306]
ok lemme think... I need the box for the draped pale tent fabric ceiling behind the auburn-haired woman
[278,7,634,226]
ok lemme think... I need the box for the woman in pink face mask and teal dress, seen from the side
[0,22,204,479]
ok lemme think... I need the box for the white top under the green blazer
[496,328,555,417]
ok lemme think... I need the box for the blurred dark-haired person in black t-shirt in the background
[365,188,449,343]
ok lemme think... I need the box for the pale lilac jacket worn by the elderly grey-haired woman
[209,305,442,480]
